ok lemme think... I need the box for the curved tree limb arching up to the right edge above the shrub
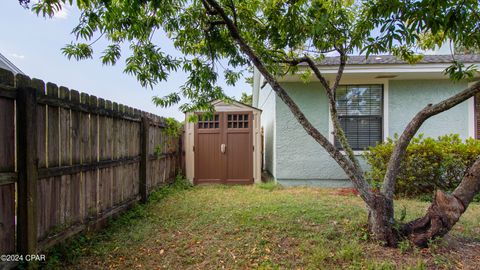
[382,82,480,199]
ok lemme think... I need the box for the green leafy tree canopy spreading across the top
[25,0,480,111]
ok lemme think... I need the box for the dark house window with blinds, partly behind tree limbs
[335,84,383,150]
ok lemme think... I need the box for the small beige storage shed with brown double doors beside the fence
[184,100,262,184]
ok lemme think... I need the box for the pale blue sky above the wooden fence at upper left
[0,0,252,120]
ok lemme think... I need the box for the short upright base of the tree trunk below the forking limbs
[368,194,398,247]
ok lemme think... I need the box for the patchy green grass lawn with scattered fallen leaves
[47,180,480,269]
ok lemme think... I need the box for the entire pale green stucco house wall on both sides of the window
[272,80,468,187]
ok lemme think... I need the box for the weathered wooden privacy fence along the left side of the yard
[0,69,183,254]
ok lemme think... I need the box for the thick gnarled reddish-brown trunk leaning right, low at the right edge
[399,158,480,247]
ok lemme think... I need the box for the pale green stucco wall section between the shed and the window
[275,82,360,186]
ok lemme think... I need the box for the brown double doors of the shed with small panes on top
[195,112,253,184]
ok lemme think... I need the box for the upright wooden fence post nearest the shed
[139,114,150,202]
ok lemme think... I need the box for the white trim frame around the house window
[328,79,389,156]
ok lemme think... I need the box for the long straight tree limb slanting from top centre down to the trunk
[204,0,374,207]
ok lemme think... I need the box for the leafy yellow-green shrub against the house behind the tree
[364,134,480,198]
